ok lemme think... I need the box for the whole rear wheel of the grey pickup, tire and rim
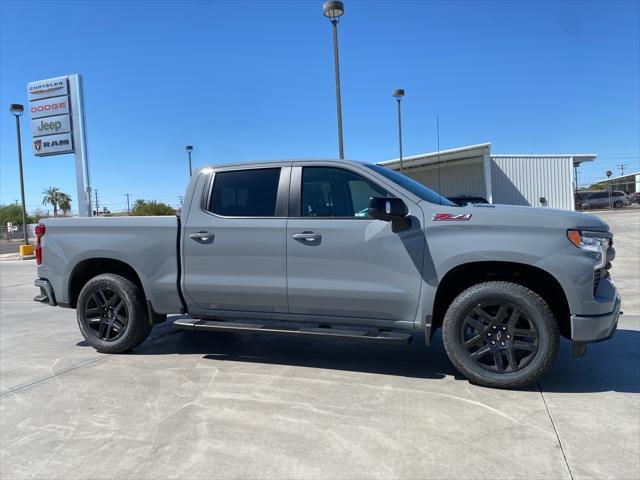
[76,273,152,353]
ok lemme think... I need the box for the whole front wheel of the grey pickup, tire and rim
[442,282,560,388]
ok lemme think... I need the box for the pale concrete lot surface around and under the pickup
[0,211,640,479]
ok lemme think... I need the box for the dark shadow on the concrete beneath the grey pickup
[133,316,640,393]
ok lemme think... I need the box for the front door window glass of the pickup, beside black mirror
[301,167,387,217]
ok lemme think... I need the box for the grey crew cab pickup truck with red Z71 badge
[35,160,620,388]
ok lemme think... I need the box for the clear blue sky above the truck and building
[0,0,640,214]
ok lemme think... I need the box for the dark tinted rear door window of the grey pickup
[209,168,280,217]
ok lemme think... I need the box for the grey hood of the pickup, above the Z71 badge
[444,204,609,231]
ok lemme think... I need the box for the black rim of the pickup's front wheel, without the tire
[461,302,539,373]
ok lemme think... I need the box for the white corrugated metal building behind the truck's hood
[379,143,596,210]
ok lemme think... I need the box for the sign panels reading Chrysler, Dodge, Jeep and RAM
[27,77,73,157]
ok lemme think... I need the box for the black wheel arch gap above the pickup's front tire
[430,261,571,338]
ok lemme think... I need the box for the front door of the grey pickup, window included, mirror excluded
[287,163,425,321]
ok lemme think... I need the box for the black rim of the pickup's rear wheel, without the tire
[85,288,129,342]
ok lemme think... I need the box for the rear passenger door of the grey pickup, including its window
[181,164,290,313]
